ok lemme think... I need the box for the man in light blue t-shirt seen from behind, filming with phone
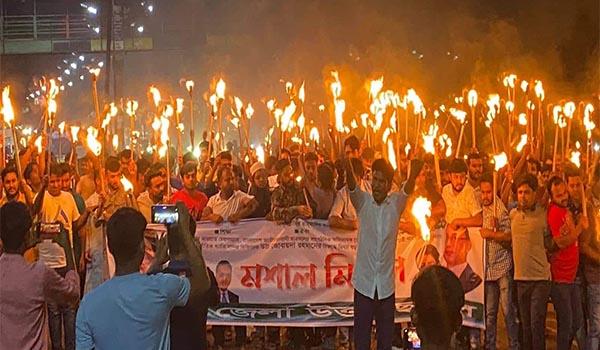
[76,203,210,350]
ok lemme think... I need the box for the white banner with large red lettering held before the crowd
[151,219,484,328]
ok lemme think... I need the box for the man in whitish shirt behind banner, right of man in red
[202,167,258,223]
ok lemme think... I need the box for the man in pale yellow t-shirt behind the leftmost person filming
[34,164,90,350]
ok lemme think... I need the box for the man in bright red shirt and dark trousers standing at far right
[547,176,588,349]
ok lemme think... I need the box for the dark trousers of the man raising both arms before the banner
[354,289,396,350]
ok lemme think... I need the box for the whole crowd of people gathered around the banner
[0,132,600,350]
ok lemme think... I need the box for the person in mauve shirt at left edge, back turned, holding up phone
[0,201,79,350]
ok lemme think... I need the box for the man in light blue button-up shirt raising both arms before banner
[346,159,423,350]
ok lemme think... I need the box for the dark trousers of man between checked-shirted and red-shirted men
[516,281,551,350]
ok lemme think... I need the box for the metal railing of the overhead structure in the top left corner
[0,14,96,40]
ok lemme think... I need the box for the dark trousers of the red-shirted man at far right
[550,282,583,349]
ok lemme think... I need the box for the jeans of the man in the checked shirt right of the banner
[485,274,519,350]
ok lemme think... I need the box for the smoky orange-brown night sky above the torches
[1,0,600,134]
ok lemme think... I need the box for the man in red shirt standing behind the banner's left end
[171,162,208,220]
